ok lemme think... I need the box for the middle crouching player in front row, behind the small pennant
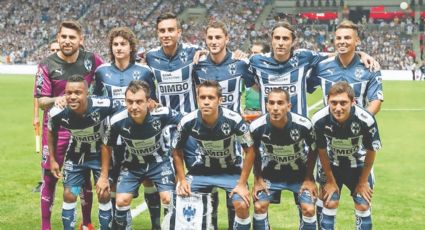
[172,80,254,229]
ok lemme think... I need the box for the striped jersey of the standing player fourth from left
[193,50,255,113]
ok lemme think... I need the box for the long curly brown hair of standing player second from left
[108,27,138,62]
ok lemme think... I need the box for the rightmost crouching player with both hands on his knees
[312,81,381,229]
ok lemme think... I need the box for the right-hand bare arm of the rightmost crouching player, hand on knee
[355,150,376,203]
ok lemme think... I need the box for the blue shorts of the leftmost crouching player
[63,159,109,187]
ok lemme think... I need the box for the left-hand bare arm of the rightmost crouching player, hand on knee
[318,148,339,204]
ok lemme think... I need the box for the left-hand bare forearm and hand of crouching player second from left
[96,144,112,198]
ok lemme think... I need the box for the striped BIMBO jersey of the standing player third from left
[146,43,200,114]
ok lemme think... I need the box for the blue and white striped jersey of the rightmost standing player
[307,55,384,107]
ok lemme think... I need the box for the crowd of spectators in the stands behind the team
[0,0,423,69]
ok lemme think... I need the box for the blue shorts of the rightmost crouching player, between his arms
[320,165,375,204]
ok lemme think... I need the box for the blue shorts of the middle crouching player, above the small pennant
[186,174,248,201]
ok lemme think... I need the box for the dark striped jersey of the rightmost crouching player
[312,105,381,168]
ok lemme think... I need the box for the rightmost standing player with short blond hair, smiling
[307,20,384,224]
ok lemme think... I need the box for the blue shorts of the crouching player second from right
[253,179,314,204]
